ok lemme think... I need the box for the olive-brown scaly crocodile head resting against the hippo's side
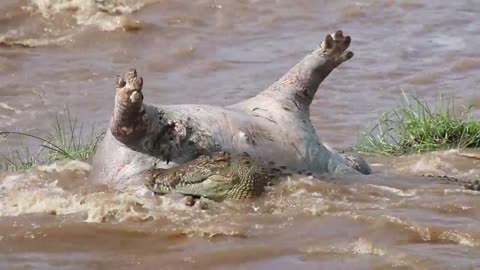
[145,152,275,201]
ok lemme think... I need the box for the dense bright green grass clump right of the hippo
[354,93,480,155]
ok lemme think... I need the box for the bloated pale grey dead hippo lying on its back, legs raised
[91,30,370,189]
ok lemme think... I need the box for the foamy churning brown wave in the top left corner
[0,0,153,48]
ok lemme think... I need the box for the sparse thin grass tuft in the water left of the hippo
[0,109,105,172]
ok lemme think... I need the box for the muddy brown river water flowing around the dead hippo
[0,0,480,269]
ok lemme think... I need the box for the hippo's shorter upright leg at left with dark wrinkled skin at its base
[110,69,210,164]
